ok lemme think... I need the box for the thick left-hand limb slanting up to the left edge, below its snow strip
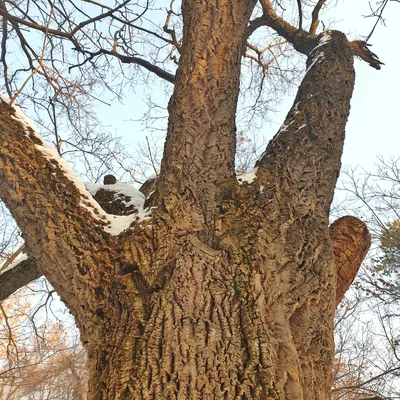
[0,100,145,340]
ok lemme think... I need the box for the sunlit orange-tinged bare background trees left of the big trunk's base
[0,280,86,400]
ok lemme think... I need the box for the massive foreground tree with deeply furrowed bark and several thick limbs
[0,0,382,399]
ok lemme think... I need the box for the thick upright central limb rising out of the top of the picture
[159,0,256,233]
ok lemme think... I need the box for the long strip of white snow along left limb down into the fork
[0,93,151,236]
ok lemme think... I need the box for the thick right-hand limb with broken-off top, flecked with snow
[257,31,354,222]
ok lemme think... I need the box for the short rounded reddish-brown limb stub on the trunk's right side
[329,216,371,304]
